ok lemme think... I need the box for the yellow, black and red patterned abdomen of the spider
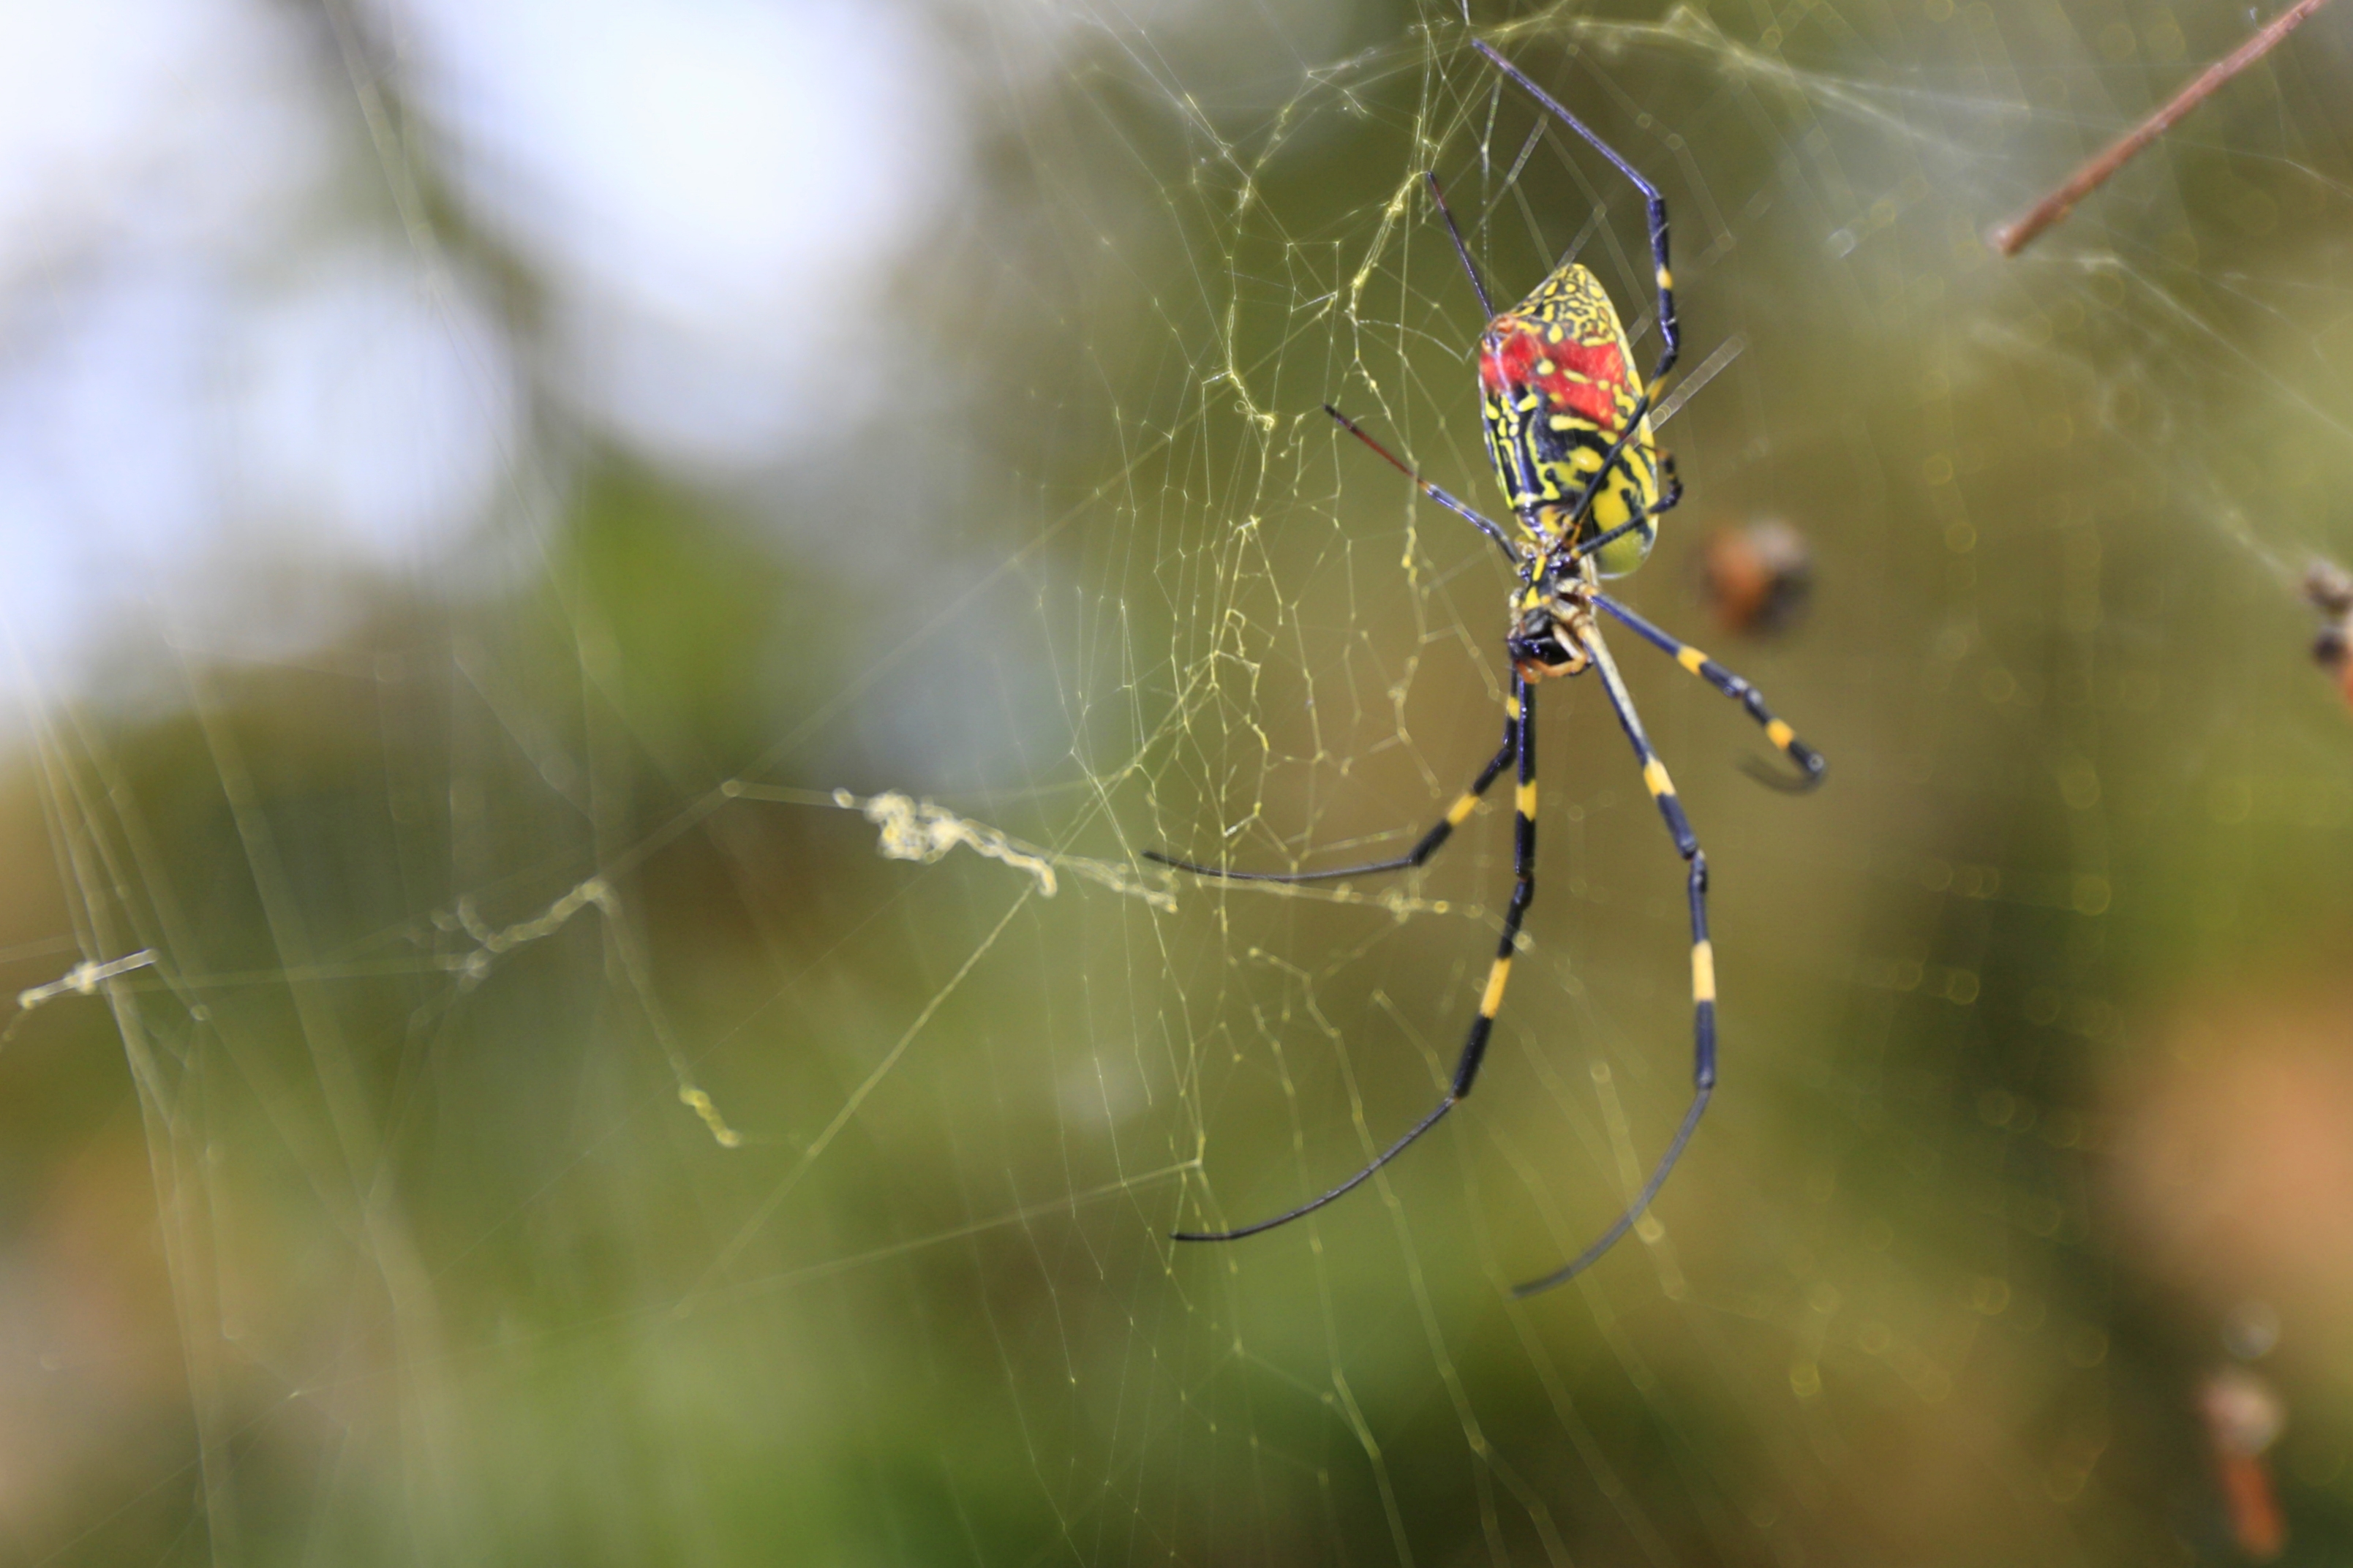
[1477,261,1659,577]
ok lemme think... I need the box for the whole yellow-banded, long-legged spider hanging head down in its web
[1146,40,1823,1295]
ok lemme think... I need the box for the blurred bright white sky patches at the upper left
[0,0,974,687]
